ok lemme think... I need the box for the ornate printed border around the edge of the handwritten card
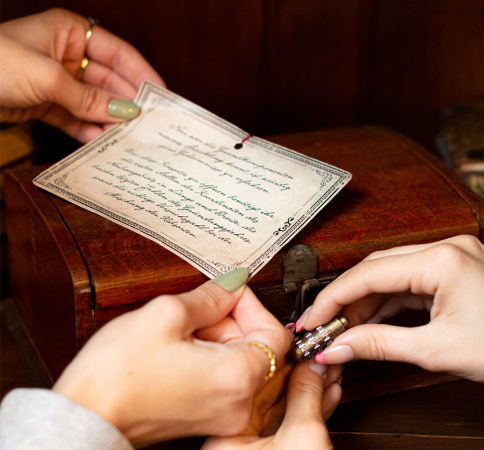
[34,82,351,277]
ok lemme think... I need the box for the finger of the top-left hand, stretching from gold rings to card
[86,25,166,89]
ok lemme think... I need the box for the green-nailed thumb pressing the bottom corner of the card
[177,267,249,333]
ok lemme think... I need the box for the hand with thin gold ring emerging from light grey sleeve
[53,269,292,445]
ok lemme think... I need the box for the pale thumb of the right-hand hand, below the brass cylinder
[315,324,425,366]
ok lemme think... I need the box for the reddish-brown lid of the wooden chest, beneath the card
[8,127,484,308]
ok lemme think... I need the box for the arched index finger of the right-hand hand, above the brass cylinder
[302,247,439,330]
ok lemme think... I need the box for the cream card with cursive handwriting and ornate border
[34,83,351,278]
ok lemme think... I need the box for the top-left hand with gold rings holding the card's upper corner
[0,9,165,142]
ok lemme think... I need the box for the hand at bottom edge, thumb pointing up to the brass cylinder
[202,360,342,450]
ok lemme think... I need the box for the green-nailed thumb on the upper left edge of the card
[48,68,140,123]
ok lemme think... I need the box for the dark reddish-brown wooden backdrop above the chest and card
[1,0,484,150]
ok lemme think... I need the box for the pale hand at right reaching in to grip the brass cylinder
[297,236,484,382]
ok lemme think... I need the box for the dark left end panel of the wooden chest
[5,168,94,379]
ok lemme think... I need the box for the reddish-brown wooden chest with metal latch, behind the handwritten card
[5,127,484,386]
